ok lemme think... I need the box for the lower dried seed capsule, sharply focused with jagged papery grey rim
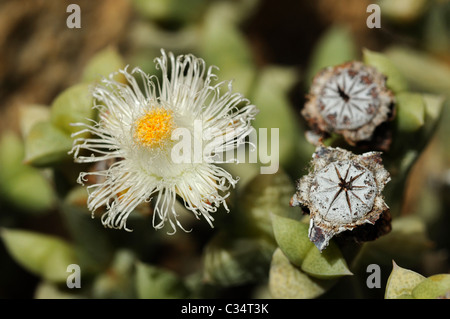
[291,146,390,250]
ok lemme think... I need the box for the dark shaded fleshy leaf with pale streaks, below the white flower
[204,233,275,286]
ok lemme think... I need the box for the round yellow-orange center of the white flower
[133,107,174,148]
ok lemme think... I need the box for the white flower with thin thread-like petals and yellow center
[71,51,258,232]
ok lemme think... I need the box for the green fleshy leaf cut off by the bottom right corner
[412,274,450,299]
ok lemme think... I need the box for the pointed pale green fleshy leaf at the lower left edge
[1,229,77,282]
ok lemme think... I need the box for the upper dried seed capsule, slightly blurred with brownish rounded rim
[302,61,394,145]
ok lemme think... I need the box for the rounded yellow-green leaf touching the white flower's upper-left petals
[50,83,96,134]
